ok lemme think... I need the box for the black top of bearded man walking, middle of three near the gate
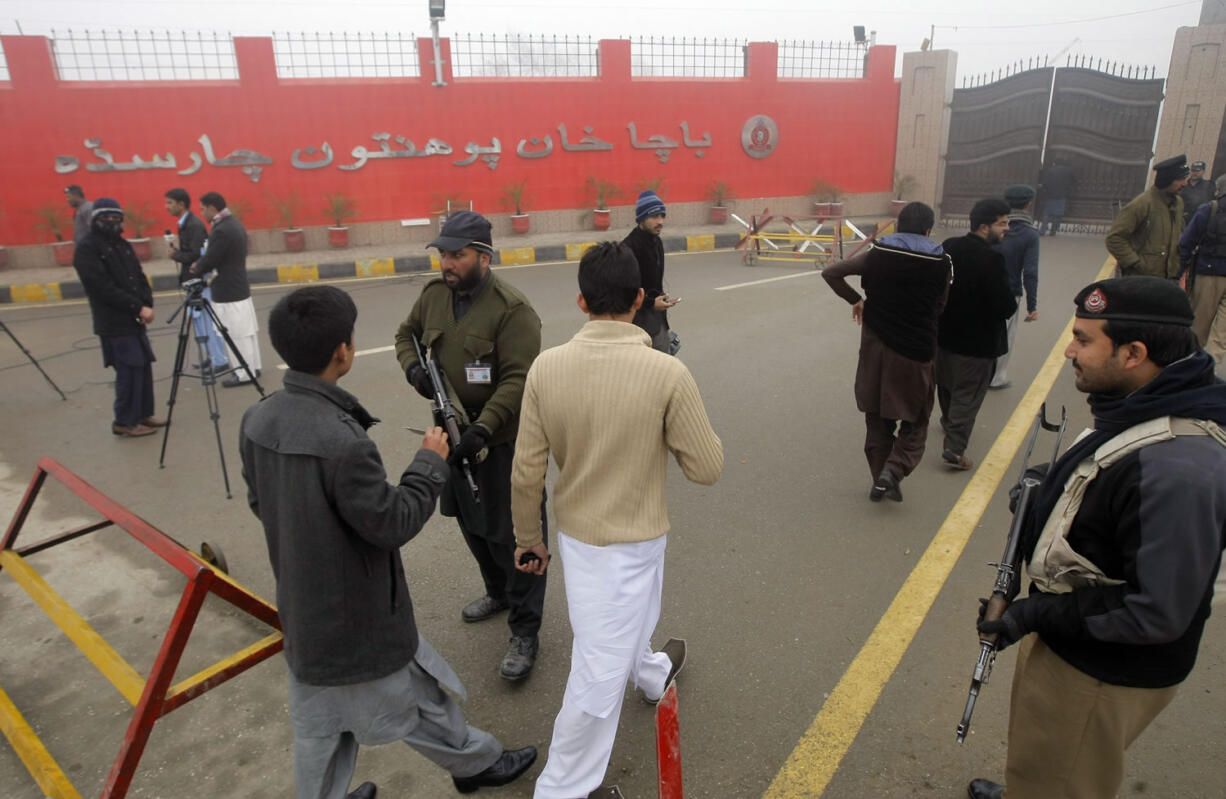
[937,233,1018,358]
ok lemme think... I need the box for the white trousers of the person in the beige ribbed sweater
[532,531,672,799]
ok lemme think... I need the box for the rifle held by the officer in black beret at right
[958,402,1068,744]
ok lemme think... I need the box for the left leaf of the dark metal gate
[940,67,1052,219]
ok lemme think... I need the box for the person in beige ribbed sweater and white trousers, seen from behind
[511,241,723,799]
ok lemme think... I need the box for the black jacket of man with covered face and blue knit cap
[72,229,153,336]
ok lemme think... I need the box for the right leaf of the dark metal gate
[1040,67,1173,224]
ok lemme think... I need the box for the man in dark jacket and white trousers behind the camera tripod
[190,191,261,388]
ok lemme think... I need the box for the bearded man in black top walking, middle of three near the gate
[937,197,1018,469]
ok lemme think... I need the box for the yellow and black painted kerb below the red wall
[0,223,744,304]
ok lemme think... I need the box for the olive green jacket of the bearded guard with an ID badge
[396,272,541,446]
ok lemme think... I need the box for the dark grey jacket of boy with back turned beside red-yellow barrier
[239,370,447,685]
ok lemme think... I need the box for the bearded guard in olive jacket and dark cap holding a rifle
[396,211,546,681]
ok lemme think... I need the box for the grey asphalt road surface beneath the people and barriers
[0,237,1226,799]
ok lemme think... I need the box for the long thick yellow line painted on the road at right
[763,259,1116,799]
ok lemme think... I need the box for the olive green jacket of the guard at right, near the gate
[1107,186,1183,279]
